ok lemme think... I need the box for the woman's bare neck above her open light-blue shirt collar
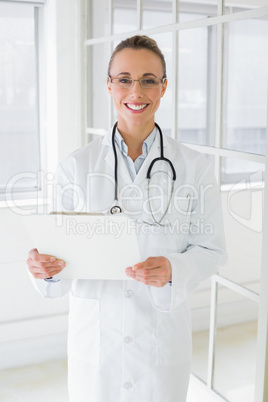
[117,121,154,161]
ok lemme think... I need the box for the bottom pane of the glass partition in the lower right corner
[214,287,258,402]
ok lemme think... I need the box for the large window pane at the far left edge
[0,2,40,192]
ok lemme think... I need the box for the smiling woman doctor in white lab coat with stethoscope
[27,36,226,402]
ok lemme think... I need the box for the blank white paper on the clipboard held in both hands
[22,214,140,280]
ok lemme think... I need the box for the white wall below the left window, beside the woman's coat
[0,208,68,369]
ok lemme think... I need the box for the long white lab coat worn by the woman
[32,130,226,402]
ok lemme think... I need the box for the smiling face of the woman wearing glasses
[107,48,167,134]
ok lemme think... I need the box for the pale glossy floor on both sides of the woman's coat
[0,323,256,402]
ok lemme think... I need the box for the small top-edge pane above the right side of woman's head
[142,0,173,28]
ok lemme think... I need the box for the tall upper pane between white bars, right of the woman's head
[178,24,215,145]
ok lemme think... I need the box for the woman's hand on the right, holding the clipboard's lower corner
[125,257,172,288]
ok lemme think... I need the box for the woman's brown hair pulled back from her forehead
[108,35,166,78]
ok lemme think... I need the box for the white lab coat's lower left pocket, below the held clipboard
[68,296,100,365]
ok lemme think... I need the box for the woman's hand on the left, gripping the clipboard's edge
[26,248,66,279]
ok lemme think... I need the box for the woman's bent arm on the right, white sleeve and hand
[126,156,226,311]
